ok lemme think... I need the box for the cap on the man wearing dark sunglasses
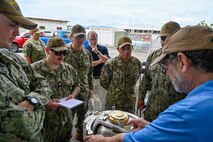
[47,37,69,52]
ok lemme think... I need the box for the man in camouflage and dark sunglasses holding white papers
[31,37,81,142]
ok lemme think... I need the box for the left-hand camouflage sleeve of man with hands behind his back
[100,59,113,90]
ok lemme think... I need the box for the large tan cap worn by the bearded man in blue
[151,26,213,66]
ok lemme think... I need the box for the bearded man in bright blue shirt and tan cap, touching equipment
[86,26,213,142]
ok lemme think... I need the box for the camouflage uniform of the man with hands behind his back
[100,56,141,113]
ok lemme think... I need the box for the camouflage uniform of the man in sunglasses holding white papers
[31,59,80,142]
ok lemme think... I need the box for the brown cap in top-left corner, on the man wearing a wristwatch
[0,0,37,29]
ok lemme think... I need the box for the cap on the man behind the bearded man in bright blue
[160,21,180,37]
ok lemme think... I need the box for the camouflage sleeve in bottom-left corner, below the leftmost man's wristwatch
[0,86,45,141]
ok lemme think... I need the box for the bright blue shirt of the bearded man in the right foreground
[124,80,213,142]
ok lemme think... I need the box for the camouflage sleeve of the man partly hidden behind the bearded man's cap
[138,54,152,100]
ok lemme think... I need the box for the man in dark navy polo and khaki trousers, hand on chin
[85,31,110,110]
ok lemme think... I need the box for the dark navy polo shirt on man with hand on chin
[85,45,110,77]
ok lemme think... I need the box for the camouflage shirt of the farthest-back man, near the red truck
[22,38,45,63]
